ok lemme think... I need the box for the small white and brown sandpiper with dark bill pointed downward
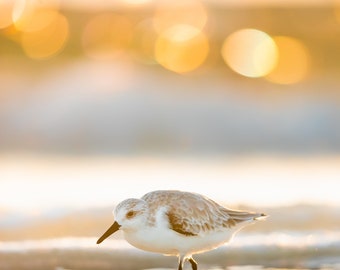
[97,190,266,270]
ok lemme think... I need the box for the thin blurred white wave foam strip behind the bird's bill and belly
[0,231,340,252]
